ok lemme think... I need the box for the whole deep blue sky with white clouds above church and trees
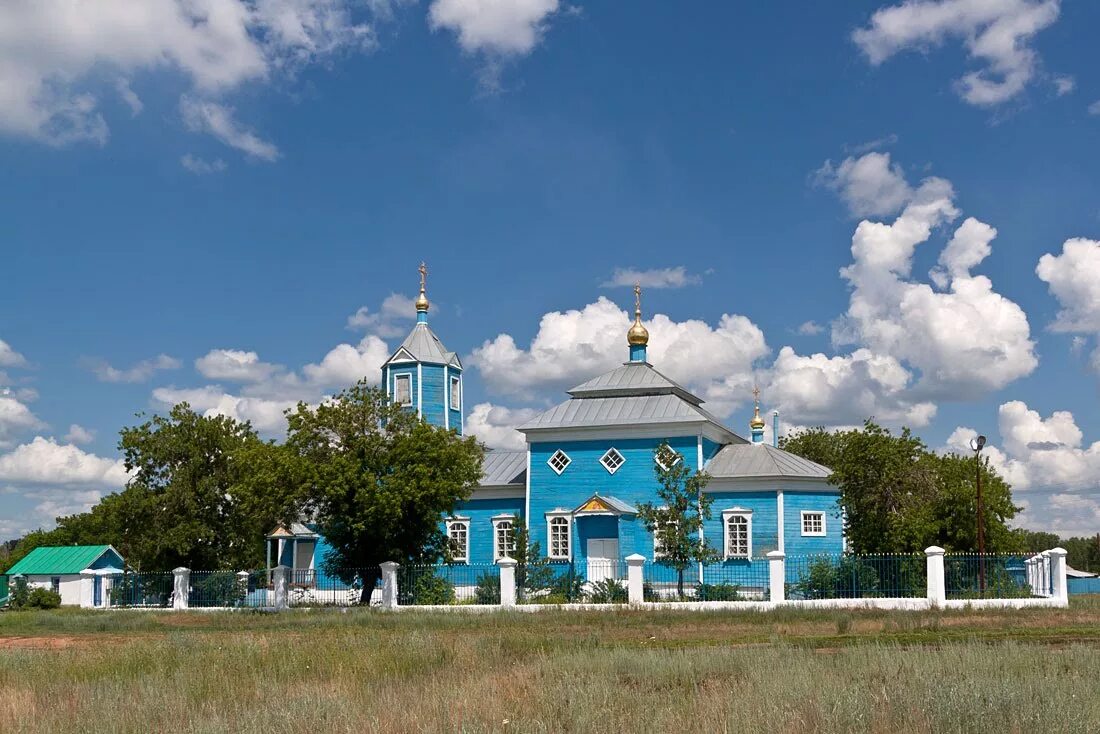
[0,0,1100,537]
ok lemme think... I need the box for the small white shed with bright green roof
[8,546,124,606]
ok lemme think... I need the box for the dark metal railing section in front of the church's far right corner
[787,554,928,599]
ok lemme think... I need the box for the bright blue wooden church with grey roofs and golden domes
[270,265,844,579]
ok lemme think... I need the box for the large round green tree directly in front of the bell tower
[275,381,484,603]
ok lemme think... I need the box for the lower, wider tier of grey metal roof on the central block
[519,393,729,431]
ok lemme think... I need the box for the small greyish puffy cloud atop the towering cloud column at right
[814,152,913,217]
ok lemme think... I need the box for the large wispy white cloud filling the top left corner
[0,0,378,151]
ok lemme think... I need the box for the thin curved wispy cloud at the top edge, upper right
[851,0,1059,107]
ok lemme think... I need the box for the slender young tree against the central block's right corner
[638,443,718,598]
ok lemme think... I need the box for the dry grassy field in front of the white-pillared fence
[0,596,1100,734]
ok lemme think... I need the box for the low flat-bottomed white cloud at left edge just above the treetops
[0,436,127,487]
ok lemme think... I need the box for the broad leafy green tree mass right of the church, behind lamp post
[781,420,1019,554]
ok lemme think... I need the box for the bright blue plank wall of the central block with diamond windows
[528,436,699,559]
